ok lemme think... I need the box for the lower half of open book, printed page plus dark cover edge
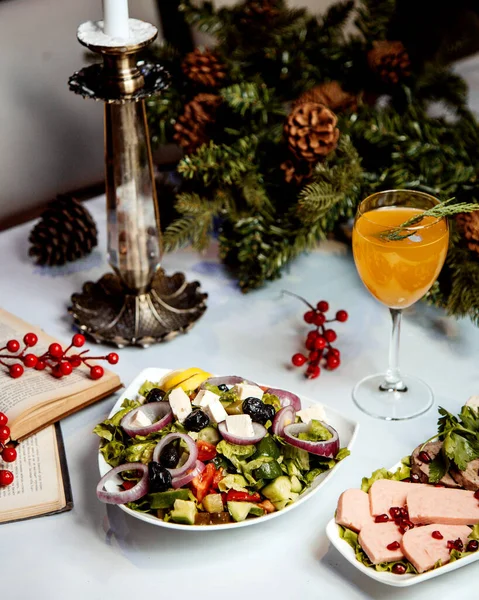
[0,424,73,523]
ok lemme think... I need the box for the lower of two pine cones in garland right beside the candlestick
[173,94,221,154]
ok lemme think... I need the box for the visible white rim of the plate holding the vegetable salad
[98,367,359,532]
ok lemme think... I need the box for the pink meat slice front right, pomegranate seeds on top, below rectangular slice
[401,523,471,573]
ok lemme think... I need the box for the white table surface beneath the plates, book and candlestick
[0,56,479,600]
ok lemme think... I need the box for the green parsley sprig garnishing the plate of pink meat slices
[423,406,479,483]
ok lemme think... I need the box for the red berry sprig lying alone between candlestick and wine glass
[284,291,349,379]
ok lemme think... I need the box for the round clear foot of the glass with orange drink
[353,373,434,421]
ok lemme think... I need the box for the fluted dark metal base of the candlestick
[69,269,207,348]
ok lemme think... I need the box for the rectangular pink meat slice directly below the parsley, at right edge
[407,485,479,525]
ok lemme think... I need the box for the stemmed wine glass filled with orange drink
[353,190,449,420]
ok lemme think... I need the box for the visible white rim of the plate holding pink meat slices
[326,462,479,587]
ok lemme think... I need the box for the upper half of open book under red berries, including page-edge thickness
[0,309,121,441]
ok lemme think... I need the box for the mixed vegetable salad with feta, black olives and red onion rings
[94,368,349,525]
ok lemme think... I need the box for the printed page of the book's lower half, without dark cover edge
[0,426,64,522]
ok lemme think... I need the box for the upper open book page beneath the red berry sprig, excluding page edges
[0,309,120,428]
